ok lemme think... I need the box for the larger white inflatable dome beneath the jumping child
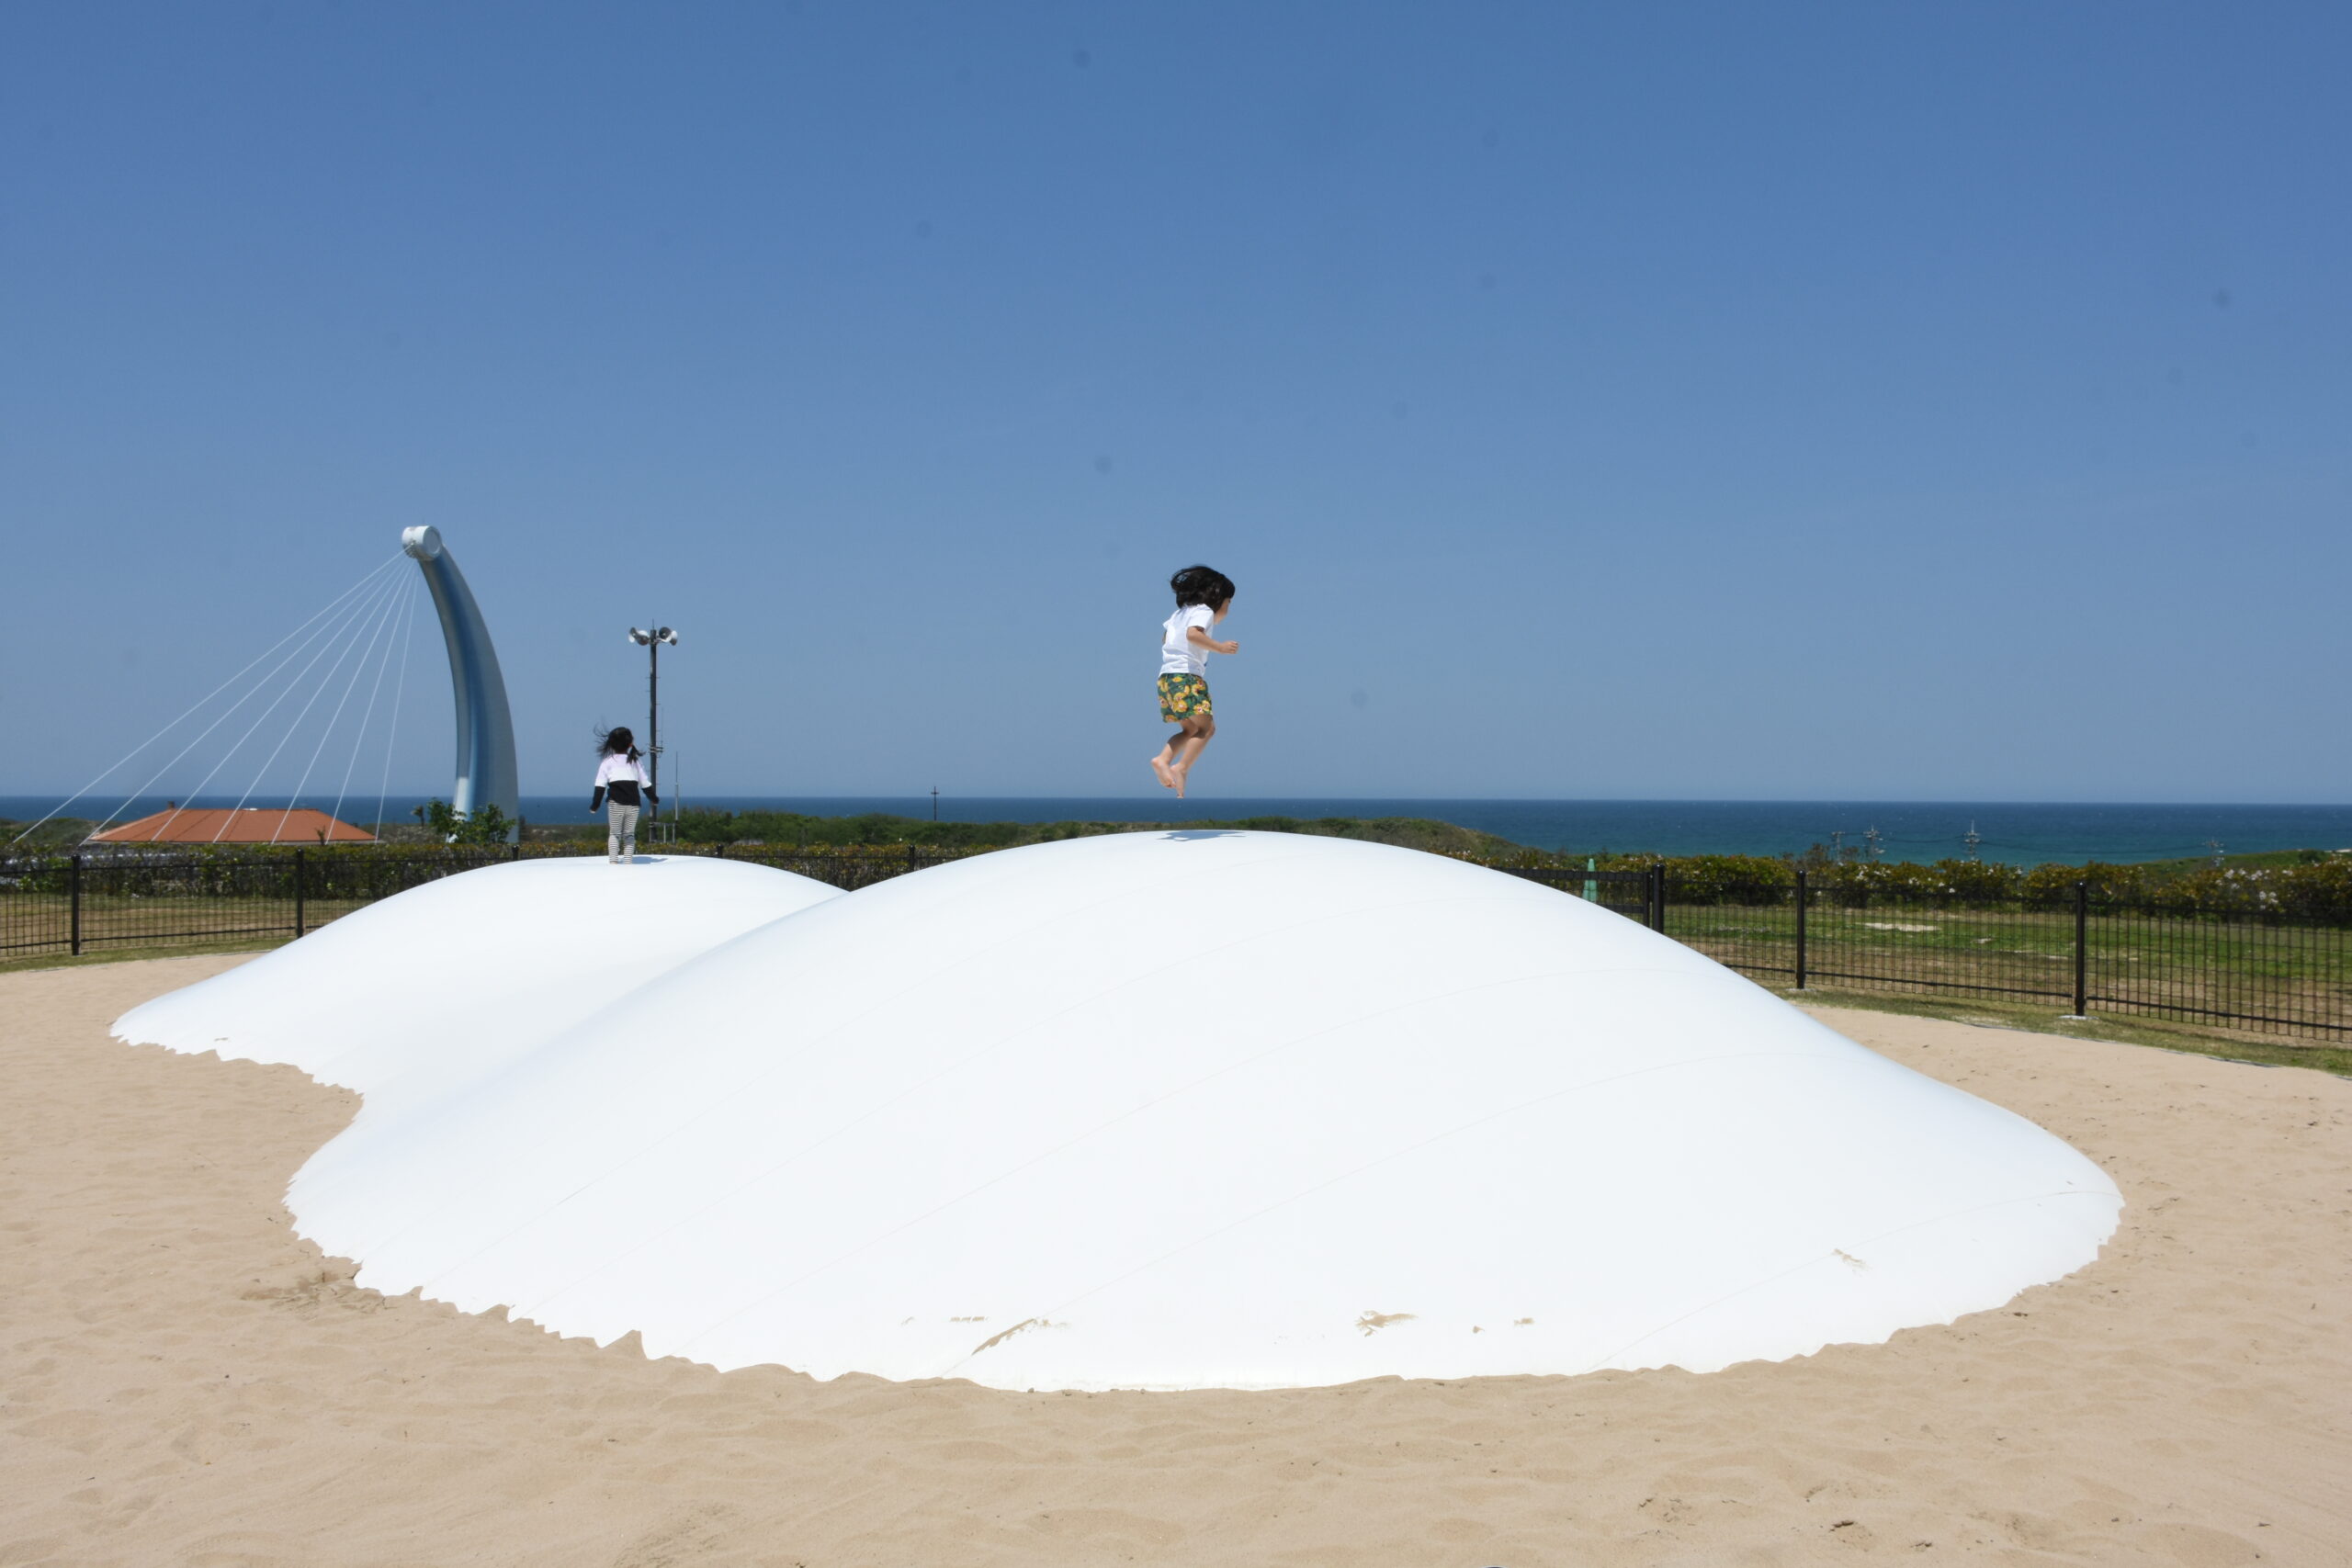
[254,832,2121,1389]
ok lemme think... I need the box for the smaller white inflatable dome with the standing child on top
[113,856,840,1131]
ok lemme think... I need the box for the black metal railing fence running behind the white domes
[0,844,2352,1039]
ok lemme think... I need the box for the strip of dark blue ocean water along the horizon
[0,792,2352,865]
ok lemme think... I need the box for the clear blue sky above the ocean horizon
[0,0,2352,802]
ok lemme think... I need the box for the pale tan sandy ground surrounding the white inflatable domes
[0,957,2352,1568]
